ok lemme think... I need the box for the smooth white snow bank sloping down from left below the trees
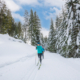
[0,34,36,67]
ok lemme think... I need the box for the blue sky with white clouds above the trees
[4,0,65,36]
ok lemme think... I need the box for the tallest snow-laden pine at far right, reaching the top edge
[67,0,80,57]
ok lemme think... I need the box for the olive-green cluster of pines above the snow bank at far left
[0,0,22,39]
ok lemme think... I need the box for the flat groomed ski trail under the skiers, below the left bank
[0,52,80,80]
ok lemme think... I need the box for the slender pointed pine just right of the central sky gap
[48,19,56,52]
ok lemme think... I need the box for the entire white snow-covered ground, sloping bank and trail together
[0,34,80,80]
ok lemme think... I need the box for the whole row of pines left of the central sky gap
[0,0,43,46]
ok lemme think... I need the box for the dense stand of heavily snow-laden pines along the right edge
[55,0,80,57]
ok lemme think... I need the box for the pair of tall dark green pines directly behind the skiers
[28,10,41,46]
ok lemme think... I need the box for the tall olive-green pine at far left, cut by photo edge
[0,1,12,35]
